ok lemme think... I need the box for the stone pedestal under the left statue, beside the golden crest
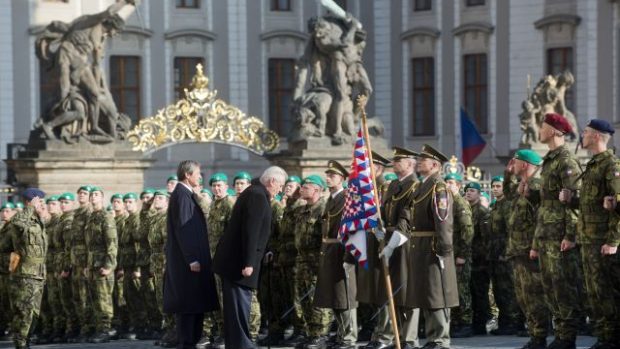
[6,140,154,198]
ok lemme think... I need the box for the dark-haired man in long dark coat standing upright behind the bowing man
[164,160,218,349]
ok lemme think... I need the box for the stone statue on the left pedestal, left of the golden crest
[34,0,136,143]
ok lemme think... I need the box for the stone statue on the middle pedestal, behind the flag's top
[290,0,372,145]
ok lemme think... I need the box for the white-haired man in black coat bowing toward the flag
[213,166,287,349]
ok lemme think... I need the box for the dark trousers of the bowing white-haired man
[222,277,256,349]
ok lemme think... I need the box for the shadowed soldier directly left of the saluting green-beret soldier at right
[487,176,523,335]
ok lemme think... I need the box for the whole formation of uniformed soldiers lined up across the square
[0,114,620,349]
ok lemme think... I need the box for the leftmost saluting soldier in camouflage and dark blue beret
[0,188,49,349]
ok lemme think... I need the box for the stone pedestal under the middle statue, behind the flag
[267,137,392,178]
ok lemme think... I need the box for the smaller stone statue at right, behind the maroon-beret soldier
[519,71,579,148]
